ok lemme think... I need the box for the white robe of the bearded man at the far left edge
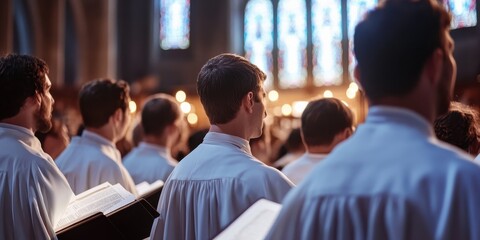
[0,123,73,239]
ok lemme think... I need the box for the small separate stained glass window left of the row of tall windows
[160,0,190,50]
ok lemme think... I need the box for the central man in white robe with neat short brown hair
[151,54,293,239]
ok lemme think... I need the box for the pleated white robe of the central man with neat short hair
[150,132,293,240]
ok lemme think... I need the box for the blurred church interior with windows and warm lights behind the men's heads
[0,0,480,142]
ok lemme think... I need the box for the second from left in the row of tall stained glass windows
[277,0,307,88]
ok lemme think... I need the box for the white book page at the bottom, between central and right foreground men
[214,199,282,240]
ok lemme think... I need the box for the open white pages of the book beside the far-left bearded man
[55,182,135,230]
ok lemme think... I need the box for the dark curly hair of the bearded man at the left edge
[0,54,48,120]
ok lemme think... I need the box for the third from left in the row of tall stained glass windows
[312,0,343,86]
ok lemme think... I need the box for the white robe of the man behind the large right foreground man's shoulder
[282,152,327,185]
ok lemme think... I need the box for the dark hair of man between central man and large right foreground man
[301,98,353,146]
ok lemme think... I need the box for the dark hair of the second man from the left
[79,79,130,128]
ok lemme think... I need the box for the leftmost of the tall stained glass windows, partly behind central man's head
[244,0,273,90]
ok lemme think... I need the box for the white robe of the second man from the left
[55,130,137,195]
